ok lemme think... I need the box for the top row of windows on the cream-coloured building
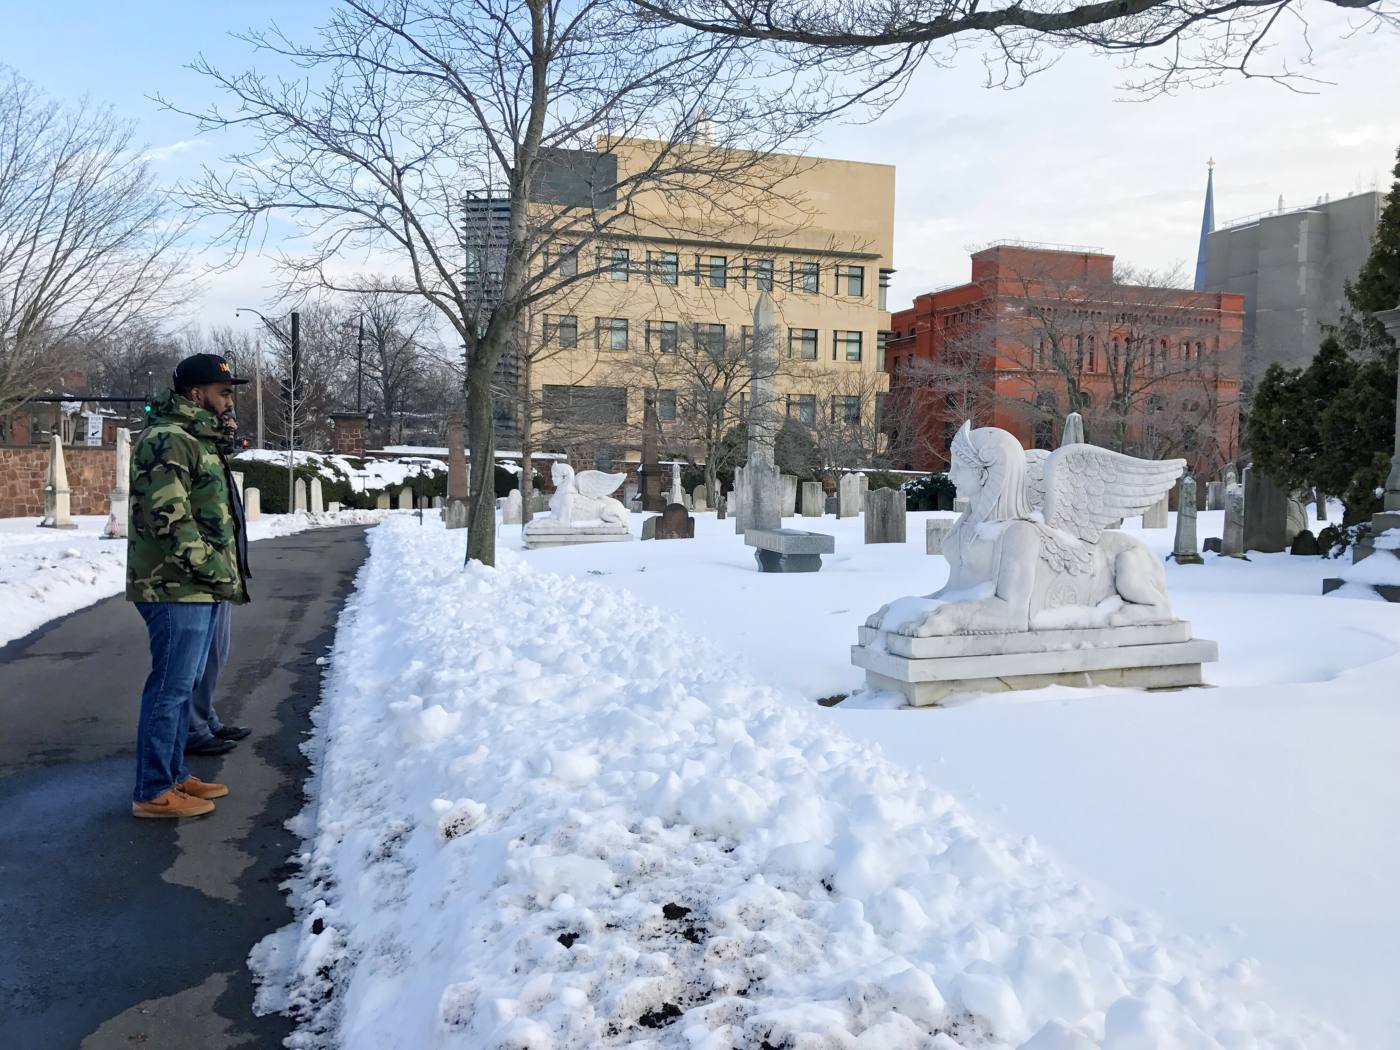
[546,248,888,309]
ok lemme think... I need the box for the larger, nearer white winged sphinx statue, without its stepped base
[867,423,1186,637]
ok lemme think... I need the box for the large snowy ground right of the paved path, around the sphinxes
[253,514,1400,1050]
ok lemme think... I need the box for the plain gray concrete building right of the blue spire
[1204,190,1386,391]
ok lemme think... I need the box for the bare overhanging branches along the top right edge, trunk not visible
[633,0,1400,98]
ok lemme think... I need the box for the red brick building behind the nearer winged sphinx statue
[885,244,1245,475]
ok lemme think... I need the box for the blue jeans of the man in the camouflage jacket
[132,602,216,802]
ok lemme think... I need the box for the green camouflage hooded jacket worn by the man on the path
[126,391,248,603]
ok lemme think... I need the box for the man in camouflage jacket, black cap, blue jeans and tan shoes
[126,354,248,816]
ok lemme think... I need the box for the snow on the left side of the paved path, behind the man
[0,511,388,645]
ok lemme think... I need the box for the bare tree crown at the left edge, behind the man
[0,67,182,428]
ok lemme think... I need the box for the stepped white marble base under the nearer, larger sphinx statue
[851,620,1219,707]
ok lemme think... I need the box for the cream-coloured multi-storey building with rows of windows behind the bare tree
[515,141,895,449]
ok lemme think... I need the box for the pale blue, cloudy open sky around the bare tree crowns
[0,0,1400,326]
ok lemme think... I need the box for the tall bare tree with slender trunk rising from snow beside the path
[179,0,818,563]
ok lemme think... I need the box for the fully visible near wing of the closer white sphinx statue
[1043,445,1186,543]
